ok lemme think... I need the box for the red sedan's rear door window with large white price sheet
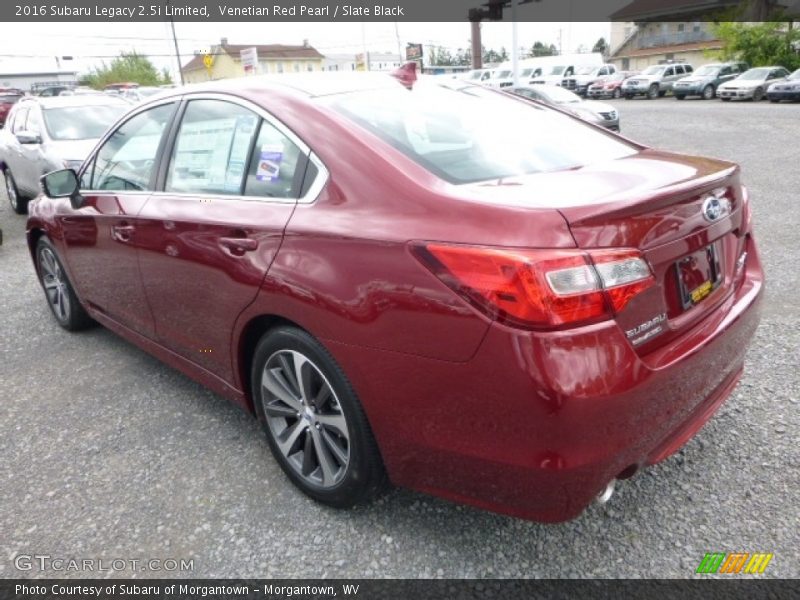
[164,100,260,196]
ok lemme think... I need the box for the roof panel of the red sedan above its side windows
[170,71,400,96]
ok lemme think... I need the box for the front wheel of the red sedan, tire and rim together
[36,237,94,331]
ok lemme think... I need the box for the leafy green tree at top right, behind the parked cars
[714,21,800,71]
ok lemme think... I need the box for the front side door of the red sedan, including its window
[57,100,179,338]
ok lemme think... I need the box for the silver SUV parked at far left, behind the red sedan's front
[0,94,130,214]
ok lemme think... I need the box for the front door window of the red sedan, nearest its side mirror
[92,102,176,191]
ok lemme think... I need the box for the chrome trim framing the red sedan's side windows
[78,92,330,204]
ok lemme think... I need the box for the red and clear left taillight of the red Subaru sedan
[412,244,655,329]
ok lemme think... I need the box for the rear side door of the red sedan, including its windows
[137,95,309,381]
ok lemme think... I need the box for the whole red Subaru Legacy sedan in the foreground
[27,74,763,521]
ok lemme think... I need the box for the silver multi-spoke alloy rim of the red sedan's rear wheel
[261,350,350,489]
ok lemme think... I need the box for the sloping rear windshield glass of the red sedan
[321,84,638,184]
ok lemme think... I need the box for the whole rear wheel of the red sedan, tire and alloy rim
[251,327,386,508]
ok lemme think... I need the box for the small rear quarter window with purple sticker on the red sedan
[244,121,306,198]
